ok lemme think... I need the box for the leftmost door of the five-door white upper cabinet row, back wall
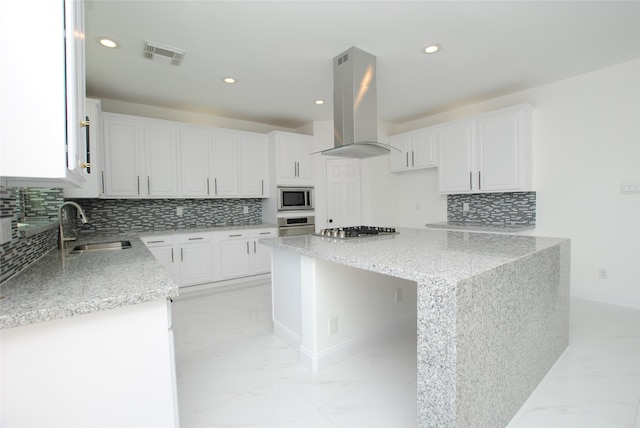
[101,114,144,197]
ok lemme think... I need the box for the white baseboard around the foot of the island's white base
[298,318,417,373]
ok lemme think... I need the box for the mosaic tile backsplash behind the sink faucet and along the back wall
[0,187,262,283]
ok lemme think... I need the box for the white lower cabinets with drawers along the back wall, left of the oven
[141,227,278,287]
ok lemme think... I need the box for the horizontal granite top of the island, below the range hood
[260,228,566,282]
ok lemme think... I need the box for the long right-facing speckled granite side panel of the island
[456,241,570,427]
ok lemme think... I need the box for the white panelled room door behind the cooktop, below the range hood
[326,159,360,227]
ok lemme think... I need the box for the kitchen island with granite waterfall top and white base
[261,229,570,427]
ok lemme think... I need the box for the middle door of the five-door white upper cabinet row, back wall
[180,127,211,198]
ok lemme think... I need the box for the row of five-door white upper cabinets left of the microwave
[101,113,269,198]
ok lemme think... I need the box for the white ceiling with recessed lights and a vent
[85,0,640,128]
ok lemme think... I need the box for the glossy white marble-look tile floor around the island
[173,284,640,428]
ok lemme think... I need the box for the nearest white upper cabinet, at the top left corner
[0,0,86,187]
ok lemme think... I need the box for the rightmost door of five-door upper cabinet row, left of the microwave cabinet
[240,135,268,198]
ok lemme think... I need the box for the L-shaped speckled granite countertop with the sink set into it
[0,224,276,329]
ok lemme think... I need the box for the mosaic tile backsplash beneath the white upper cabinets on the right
[447,192,536,226]
